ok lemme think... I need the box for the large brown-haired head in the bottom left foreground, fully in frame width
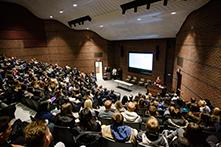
[24,121,53,147]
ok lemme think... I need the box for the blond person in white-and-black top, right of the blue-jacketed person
[137,116,169,147]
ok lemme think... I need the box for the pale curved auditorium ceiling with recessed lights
[0,0,209,40]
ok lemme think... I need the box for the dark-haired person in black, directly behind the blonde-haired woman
[79,108,101,132]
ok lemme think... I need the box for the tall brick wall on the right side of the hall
[173,0,221,106]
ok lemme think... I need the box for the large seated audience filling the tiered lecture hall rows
[0,57,221,147]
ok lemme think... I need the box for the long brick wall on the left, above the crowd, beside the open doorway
[0,3,108,73]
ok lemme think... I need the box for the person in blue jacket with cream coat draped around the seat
[101,113,138,143]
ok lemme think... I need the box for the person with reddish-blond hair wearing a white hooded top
[121,102,142,123]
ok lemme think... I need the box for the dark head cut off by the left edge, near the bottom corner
[0,116,12,143]
